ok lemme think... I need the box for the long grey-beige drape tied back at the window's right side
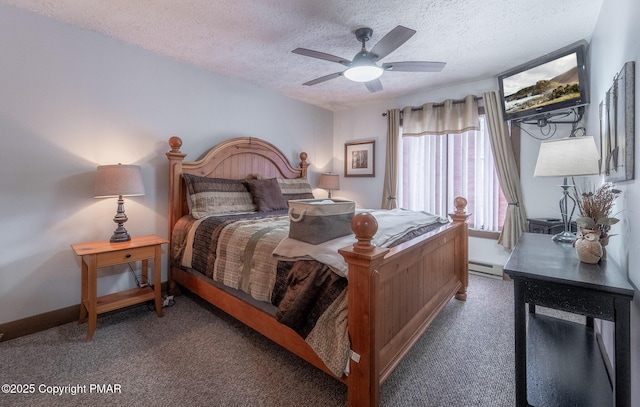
[482,92,527,249]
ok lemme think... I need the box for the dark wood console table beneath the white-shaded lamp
[504,233,634,407]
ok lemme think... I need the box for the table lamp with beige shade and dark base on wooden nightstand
[95,164,144,242]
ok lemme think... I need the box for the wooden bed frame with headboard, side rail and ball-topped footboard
[167,137,468,407]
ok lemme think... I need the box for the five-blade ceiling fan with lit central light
[291,25,446,92]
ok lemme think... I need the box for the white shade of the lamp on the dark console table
[533,136,600,177]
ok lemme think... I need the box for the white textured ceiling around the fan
[0,0,602,110]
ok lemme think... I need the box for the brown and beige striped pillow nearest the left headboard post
[183,174,256,219]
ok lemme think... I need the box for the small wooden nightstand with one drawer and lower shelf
[71,235,169,341]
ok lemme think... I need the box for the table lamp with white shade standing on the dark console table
[533,136,600,243]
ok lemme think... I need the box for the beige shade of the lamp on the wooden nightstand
[95,164,144,198]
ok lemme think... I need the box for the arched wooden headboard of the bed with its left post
[167,136,309,239]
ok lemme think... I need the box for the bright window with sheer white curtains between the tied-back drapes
[398,115,507,232]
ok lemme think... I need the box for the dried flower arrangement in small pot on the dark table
[574,182,622,263]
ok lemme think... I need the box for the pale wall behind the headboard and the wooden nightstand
[0,4,333,323]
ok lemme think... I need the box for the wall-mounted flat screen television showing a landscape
[498,40,589,121]
